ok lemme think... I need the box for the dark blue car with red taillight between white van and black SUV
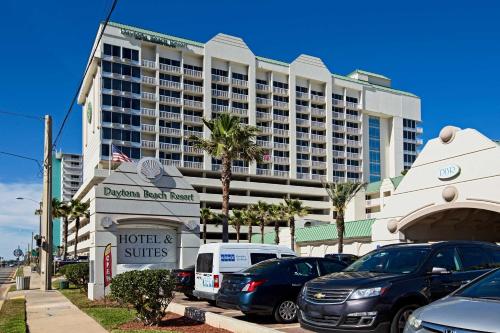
[217,257,346,323]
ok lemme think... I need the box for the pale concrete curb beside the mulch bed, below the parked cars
[167,302,280,333]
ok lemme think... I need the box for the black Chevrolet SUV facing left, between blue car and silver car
[297,241,500,333]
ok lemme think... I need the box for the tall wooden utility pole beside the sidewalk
[40,115,52,291]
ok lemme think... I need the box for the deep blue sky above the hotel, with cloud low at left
[0,0,500,256]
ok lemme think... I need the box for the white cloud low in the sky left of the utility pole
[0,183,42,258]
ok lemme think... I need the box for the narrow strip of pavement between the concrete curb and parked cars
[174,294,311,333]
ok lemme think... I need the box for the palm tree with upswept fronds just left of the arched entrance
[323,182,364,253]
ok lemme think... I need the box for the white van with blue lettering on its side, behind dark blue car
[193,243,296,301]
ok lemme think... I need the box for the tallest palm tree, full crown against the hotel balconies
[189,113,264,243]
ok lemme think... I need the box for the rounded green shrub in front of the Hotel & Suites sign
[111,269,176,325]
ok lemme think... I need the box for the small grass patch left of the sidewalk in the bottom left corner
[0,298,26,333]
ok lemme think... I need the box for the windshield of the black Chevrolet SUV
[344,247,429,274]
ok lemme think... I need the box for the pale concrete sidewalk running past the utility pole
[9,267,108,333]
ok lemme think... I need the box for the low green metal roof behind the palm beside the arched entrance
[295,219,375,243]
